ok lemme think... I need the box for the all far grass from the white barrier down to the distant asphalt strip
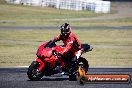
[0,1,132,26]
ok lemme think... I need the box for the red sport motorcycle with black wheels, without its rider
[27,41,92,81]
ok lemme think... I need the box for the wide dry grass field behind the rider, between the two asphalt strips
[0,29,132,67]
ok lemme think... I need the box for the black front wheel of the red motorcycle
[27,61,43,81]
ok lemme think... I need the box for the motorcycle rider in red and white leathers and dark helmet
[51,23,82,62]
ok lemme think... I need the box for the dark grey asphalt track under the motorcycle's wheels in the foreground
[0,68,132,88]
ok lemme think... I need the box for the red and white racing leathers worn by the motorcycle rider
[52,33,82,59]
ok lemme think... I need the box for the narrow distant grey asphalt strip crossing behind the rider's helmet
[0,26,132,30]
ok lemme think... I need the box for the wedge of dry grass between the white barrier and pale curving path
[0,4,103,25]
